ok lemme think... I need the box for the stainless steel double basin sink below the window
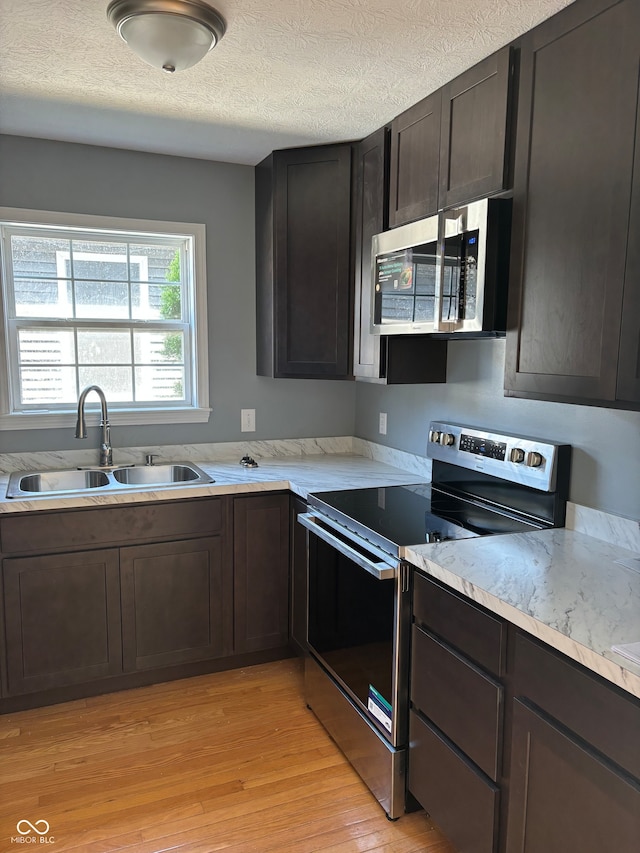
[7,462,214,498]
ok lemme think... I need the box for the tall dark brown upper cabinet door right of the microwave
[505,0,640,401]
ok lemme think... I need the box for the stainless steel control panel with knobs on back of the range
[427,421,568,492]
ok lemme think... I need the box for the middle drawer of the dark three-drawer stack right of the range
[411,625,503,781]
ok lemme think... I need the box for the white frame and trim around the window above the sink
[0,207,211,430]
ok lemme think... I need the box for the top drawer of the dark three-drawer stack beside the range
[413,572,506,676]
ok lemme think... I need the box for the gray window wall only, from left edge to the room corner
[0,135,355,453]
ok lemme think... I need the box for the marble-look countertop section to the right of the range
[403,528,640,697]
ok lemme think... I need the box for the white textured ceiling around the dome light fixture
[0,0,569,164]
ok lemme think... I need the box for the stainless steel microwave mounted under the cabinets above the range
[371,198,511,337]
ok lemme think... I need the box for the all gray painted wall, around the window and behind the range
[0,136,640,519]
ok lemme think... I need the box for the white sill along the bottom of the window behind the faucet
[0,406,211,430]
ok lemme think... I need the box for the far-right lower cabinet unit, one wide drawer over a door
[506,636,640,853]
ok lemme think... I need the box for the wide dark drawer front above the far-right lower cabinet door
[514,633,640,779]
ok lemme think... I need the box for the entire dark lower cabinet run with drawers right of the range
[407,572,640,853]
